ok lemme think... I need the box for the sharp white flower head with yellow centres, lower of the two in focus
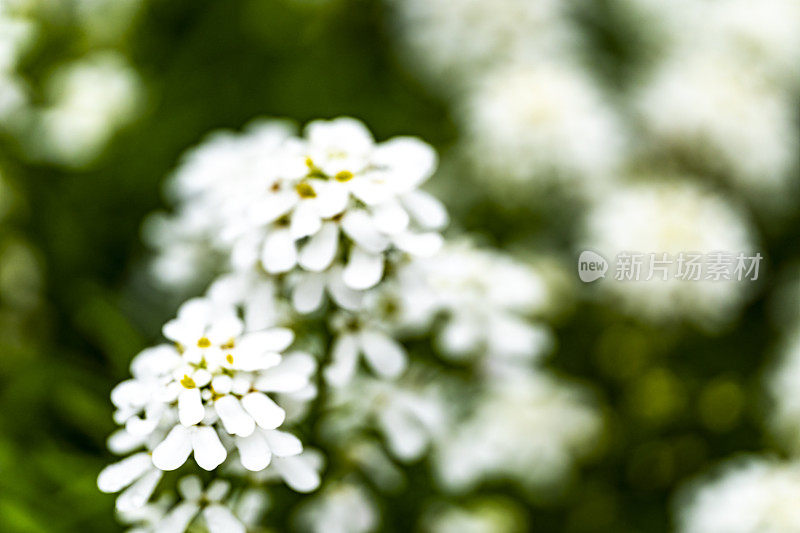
[98,298,316,511]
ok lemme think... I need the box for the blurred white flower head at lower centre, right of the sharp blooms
[434,369,600,491]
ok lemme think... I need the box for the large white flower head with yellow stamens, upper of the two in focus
[149,118,447,296]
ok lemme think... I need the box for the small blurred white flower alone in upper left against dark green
[34,52,142,167]
